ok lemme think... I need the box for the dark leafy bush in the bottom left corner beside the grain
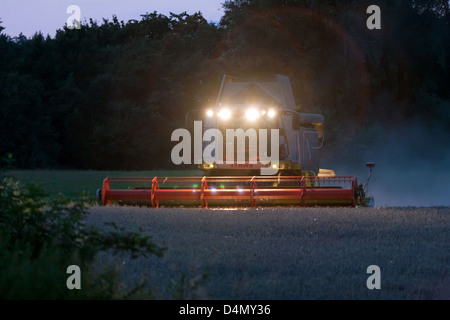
[0,177,165,299]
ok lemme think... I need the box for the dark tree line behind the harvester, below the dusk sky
[0,0,450,170]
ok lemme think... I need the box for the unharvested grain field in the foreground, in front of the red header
[87,206,450,300]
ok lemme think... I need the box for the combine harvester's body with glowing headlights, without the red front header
[186,75,335,177]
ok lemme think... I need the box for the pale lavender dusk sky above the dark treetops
[0,0,225,37]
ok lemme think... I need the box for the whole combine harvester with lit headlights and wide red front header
[97,75,375,208]
